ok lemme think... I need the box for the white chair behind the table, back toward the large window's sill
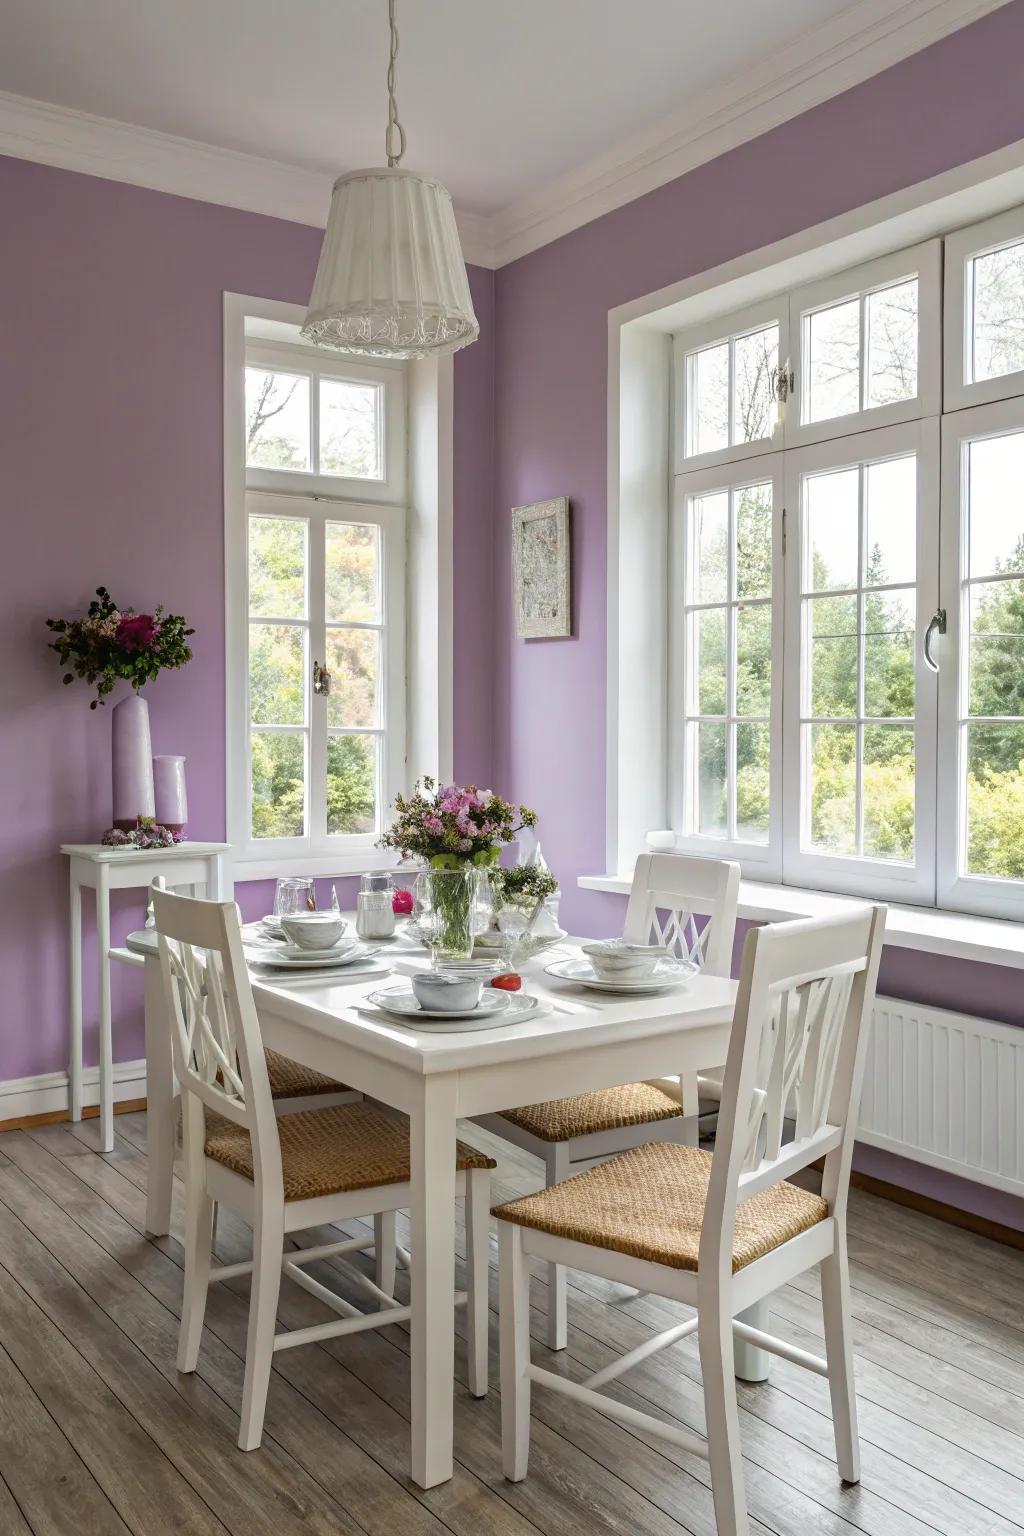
[474,854,740,1349]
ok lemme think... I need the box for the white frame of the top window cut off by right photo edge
[944,207,1024,413]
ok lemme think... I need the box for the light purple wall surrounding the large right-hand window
[494,0,1024,1224]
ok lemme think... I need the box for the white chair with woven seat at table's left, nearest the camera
[154,891,494,1450]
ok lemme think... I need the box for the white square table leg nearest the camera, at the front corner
[410,1077,456,1488]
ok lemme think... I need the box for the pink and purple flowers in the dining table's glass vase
[378,777,537,869]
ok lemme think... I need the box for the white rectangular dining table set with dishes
[120,929,746,1488]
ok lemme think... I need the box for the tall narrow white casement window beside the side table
[226,327,405,869]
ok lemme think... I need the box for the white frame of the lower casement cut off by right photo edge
[936,398,1024,920]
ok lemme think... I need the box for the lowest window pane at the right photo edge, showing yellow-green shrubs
[966,725,1024,880]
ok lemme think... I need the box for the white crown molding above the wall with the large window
[490,0,1007,267]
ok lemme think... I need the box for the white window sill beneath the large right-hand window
[576,874,1024,971]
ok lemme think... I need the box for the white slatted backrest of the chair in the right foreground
[700,906,886,1273]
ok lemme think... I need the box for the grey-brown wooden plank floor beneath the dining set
[0,1114,1024,1536]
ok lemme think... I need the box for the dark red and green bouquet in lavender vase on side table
[46,587,195,710]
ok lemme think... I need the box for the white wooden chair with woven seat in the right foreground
[494,906,886,1536]
